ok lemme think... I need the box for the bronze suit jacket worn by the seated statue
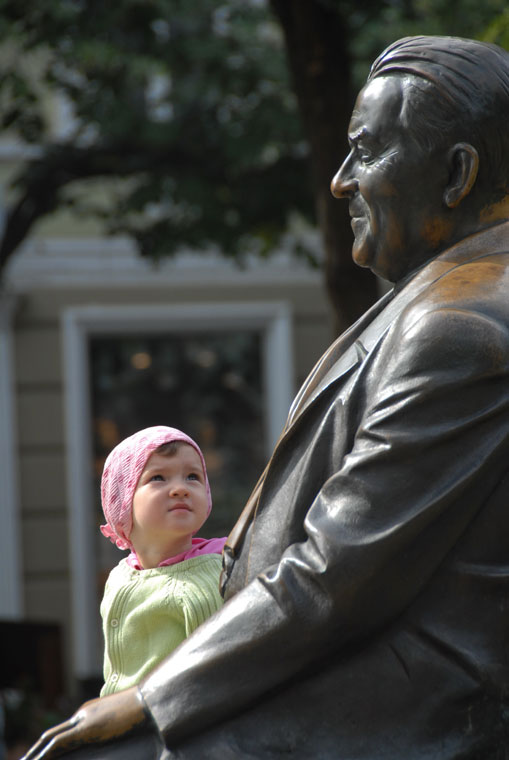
[107,223,509,760]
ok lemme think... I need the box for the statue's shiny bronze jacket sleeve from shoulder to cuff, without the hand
[141,310,509,747]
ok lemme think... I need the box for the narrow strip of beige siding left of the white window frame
[15,304,72,688]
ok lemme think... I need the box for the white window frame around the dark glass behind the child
[62,301,293,678]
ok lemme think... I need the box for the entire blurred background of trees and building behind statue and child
[0,0,509,760]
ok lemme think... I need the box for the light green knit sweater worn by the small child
[101,554,223,697]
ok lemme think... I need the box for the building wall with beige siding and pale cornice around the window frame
[7,240,332,692]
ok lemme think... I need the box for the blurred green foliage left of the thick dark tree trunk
[0,0,313,270]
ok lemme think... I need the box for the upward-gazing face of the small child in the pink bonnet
[129,443,208,556]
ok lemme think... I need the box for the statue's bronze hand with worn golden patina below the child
[23,687,149,760]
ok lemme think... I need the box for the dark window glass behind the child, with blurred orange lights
[89,331,265,580]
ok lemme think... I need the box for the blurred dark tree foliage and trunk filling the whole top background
[0,0,509,330]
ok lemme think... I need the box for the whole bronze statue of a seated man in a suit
[27,37,509,760]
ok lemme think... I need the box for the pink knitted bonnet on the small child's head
[100,425,212,549]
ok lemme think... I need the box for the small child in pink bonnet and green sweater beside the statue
[101,426,226,696]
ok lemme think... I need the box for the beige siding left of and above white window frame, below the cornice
[10,262,331,689]
